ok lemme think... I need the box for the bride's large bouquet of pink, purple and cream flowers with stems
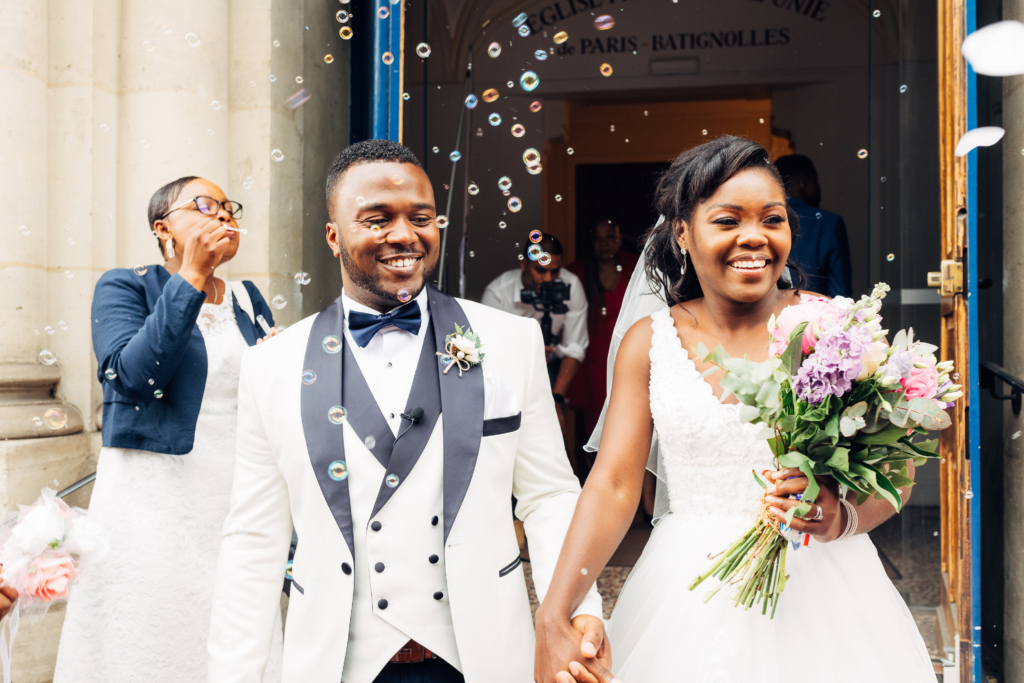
[689,284,963,616]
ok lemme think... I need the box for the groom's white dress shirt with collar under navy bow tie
[341,288,430,436]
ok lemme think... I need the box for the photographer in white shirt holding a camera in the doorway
[480,233,589,434]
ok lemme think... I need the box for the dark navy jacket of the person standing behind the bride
[790,197,853,297]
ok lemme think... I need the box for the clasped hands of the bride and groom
[534,606,620,683]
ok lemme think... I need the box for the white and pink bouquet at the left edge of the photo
[0,488,110,683]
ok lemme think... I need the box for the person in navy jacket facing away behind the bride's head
[775,155,853,297]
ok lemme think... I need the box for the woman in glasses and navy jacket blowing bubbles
[54,177,285,683]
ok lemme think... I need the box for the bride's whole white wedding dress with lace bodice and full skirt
[608,309,936,683]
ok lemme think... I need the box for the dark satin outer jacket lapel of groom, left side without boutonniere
[295,297,355,557]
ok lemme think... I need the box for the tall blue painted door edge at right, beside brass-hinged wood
[961,0,985,683]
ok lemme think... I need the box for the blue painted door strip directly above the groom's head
[370,0,404,142]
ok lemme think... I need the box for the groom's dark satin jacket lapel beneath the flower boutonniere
[428,287,485,541]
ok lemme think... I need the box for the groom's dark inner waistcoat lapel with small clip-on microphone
[372,321,441,517]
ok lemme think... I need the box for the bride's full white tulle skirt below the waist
[608,514,936,683]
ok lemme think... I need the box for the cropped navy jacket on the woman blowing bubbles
[92,265,273,456]
